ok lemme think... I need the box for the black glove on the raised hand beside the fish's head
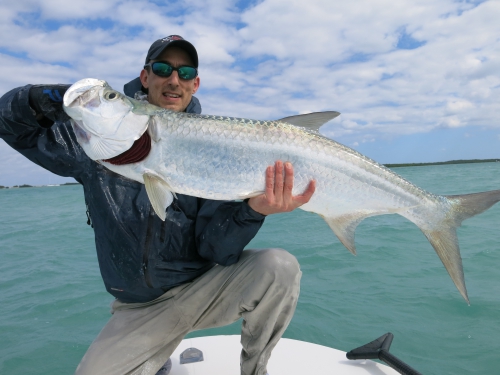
[28,85,71,128]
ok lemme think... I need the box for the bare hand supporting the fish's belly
[248,160,316,215]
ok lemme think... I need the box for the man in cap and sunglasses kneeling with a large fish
[0,35,315,375]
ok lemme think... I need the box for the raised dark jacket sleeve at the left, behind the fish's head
[0,85,90,180]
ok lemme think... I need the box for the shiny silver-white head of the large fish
[63,78,150,160]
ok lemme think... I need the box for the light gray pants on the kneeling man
[76,249,301,375]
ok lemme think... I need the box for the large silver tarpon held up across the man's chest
[64,79,500,302]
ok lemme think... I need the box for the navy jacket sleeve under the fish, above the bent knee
[196,199,265,266]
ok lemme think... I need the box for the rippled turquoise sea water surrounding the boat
[0,163,500,375]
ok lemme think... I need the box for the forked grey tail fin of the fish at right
[420,190,500,303]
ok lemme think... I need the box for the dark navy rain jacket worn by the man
[0,85,264,302]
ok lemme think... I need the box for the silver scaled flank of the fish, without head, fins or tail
[142,111,442,222]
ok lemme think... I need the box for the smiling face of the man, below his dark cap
[141,47,200,112]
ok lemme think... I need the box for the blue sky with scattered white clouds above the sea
[0,0,500,186]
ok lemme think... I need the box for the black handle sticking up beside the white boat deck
[346,332,422,375]
